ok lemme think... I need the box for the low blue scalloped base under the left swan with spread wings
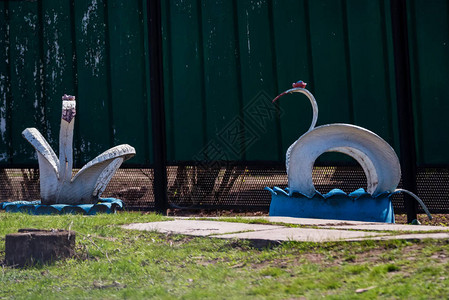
[0,198,123,215]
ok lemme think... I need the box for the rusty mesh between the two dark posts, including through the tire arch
[167,165,405,212]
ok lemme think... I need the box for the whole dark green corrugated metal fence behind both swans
[0,0,449,166]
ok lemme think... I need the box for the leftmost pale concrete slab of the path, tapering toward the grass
[123,219,284,236]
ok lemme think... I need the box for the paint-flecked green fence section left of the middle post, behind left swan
[0,0,152,165]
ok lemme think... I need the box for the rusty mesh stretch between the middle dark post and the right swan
[167,165,287,209]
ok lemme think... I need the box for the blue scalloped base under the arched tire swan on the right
[265,187,394,223]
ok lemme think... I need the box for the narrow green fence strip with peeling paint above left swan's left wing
[8,1,45,163]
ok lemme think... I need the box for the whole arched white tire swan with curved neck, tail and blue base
[267,81,432,223]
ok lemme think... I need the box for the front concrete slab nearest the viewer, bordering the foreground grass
[214,227,386,243]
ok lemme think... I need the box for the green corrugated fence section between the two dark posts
[163,0,397,161]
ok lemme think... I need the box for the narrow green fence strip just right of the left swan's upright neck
[74,0,112,163]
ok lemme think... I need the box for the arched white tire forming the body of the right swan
[287,124,401,197]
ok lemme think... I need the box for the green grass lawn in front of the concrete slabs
[0,213,449,299]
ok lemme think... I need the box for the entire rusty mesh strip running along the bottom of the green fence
[0,165,449,213]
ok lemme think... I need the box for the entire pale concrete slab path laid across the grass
[122,217,449,248]
